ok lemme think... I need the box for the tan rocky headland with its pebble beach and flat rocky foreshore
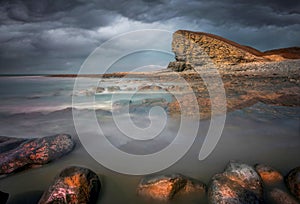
[65,30,300,119]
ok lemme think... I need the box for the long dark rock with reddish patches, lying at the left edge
[0,134,75,175]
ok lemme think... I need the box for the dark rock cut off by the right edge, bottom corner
[285,167,300,200]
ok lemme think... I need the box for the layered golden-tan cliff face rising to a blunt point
[168,30,298,71]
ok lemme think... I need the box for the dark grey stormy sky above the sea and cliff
[0,0,300,74]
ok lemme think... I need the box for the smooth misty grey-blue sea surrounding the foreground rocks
[0,76,300,204]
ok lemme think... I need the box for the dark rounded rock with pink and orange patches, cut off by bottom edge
[39,166,101,204]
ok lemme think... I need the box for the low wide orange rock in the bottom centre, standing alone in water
[137,174,206,200]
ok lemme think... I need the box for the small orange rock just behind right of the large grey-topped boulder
[255,164,283,185]
